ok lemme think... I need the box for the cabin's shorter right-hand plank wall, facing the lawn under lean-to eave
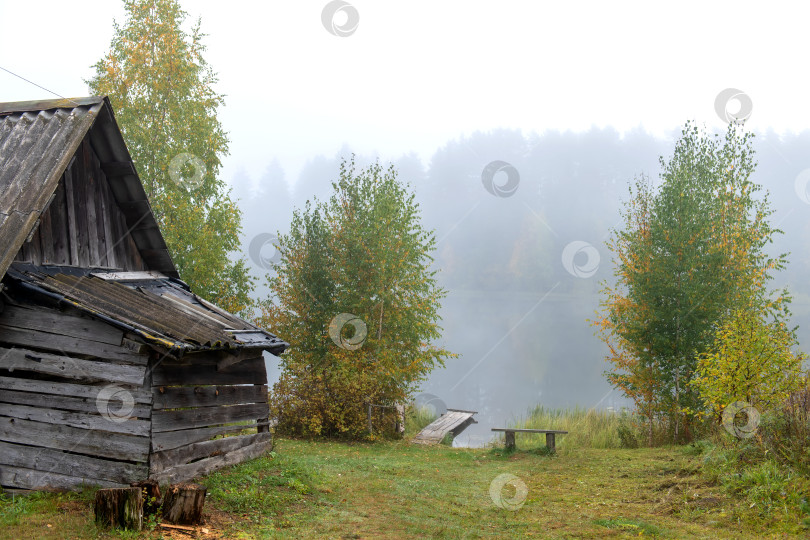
[149,349,273,482]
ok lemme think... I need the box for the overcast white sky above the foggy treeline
[0,0,810,186]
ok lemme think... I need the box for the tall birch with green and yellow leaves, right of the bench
[594,123,790,443]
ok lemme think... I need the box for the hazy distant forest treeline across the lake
[233,128,810,300]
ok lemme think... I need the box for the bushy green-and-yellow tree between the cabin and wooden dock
[256,159,456,439]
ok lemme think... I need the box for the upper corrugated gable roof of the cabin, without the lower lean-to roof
[0,96,178,278]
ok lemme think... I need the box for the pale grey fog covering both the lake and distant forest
[230,127,810,446]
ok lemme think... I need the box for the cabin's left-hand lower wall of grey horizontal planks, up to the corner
[0,299,152,489]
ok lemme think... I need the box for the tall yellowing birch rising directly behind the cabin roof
[87,0,254,312]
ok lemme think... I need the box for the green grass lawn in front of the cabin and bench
[0,435,807,539]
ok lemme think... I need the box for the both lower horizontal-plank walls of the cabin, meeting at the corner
[0,298,273,489]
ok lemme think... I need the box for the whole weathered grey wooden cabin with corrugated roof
[0,97,288,489]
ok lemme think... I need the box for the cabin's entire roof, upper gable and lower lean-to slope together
[0,96,289,356]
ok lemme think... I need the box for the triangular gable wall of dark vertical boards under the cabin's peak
[16,139,147,271]
